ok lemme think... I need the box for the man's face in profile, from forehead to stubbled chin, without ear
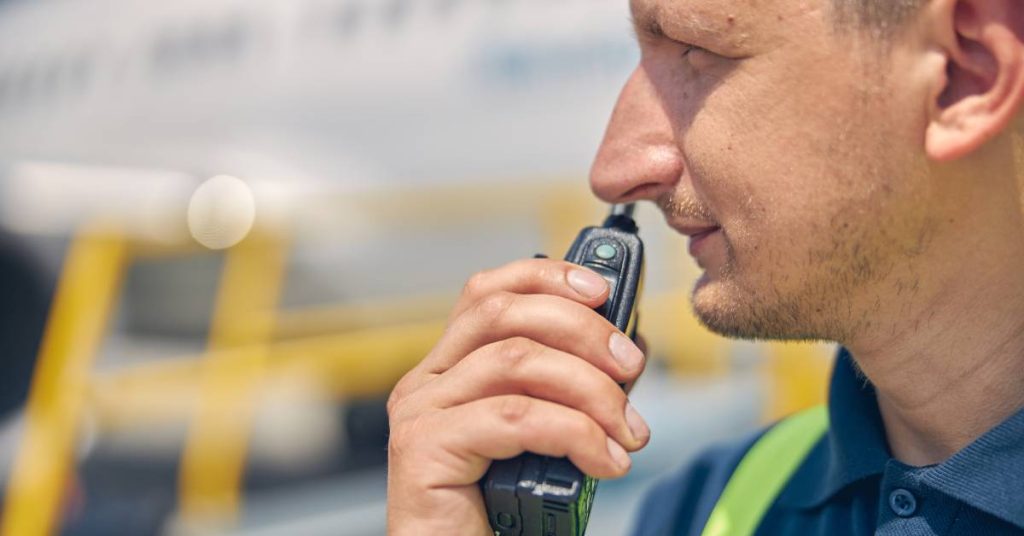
[591,0,937,341]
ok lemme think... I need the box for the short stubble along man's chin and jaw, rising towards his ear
[675,48,933,343]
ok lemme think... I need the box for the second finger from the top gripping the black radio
[424,292,644,383]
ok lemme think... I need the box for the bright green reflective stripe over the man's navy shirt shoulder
[702,406,828,536]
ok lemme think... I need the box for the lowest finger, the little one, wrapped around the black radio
[420,396,632,486]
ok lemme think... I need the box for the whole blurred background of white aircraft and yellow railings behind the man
[0,0,831,536]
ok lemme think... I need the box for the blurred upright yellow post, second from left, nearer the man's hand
[179,230,287,523]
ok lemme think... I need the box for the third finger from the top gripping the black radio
[409,337,650,450]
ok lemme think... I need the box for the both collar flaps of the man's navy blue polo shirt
[779,348,1024,528]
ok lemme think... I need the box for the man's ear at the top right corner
[925,0,1024,161]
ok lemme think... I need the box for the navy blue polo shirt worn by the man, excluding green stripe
[633,351,1024,536]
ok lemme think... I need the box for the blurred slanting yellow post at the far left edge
[2,230,126,536]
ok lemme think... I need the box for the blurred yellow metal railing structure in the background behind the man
[2,184,828,536]
